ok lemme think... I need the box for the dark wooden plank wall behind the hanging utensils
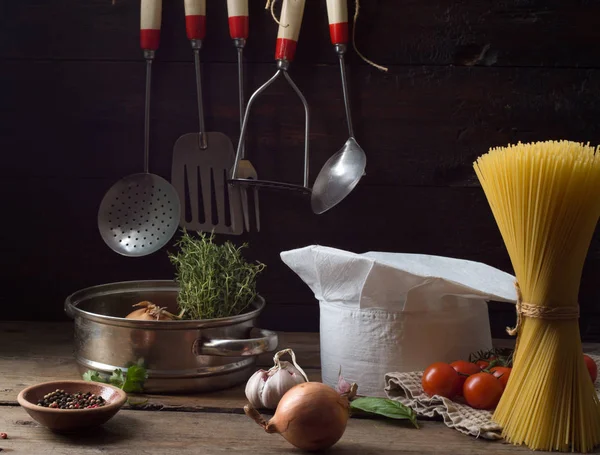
[0,0,600,341]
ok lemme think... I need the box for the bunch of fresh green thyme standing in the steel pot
[169,229,265,319]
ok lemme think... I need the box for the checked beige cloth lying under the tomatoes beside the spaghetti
[385,353,600,440]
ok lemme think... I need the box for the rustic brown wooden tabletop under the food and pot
[0,322,596,455]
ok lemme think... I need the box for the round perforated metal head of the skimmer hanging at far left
[98,173,181,256]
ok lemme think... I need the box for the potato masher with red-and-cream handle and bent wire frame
[229,0,311,194]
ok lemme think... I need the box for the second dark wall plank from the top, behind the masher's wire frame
[0,61,600,187]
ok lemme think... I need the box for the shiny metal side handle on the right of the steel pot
[192,329,279,357]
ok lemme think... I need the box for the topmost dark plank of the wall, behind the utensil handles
[0,0,600,67]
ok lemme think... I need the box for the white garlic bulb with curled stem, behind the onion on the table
[245,349,308,409]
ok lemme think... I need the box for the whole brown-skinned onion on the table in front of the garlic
[244,382,356,450]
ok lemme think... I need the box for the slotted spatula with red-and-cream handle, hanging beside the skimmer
[171,0,243,235]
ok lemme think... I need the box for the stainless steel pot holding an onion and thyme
[65,280,278,393]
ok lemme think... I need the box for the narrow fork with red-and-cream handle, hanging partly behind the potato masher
[227,0,260,232]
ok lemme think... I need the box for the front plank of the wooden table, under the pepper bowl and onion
[0,406,552,455]
